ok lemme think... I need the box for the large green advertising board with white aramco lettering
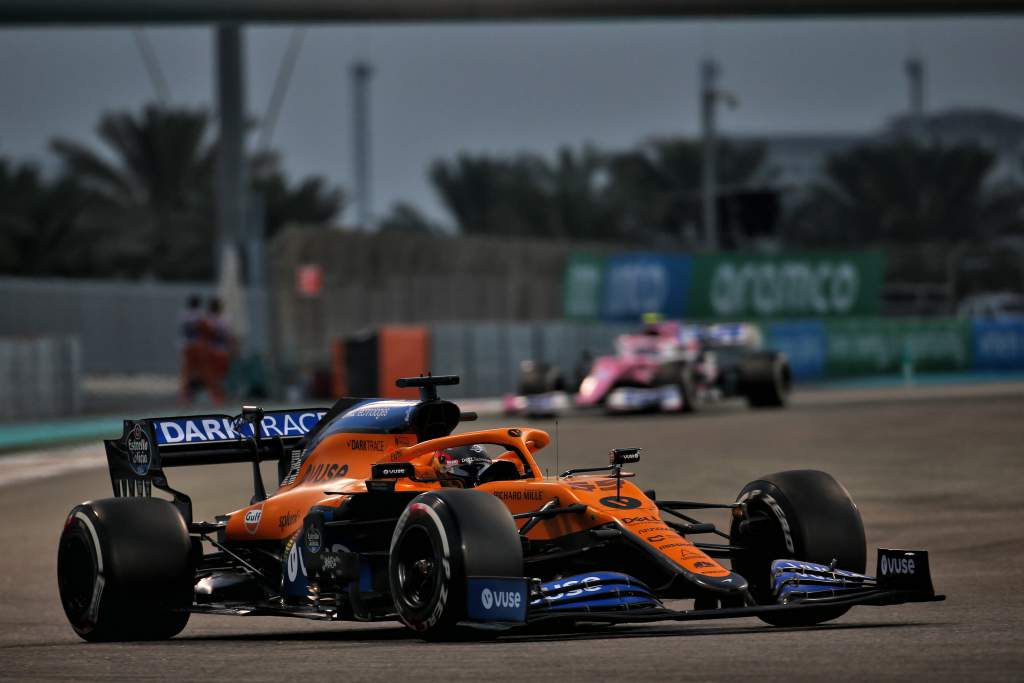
[686,251,885,318]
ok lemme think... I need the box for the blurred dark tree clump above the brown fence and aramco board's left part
[381,138,765,246]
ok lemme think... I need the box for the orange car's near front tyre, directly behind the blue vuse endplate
[388,488,523,640]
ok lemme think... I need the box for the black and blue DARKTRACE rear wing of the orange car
[103,407,329,523]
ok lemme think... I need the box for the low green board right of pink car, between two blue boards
[825,318,971,376]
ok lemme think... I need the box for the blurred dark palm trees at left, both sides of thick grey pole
[0,105,345,280]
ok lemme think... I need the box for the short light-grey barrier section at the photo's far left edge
[0,337,82,420]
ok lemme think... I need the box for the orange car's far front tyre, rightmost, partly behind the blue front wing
[729,470,867,626]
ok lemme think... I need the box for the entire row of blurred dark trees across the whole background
[0,101,1024,280]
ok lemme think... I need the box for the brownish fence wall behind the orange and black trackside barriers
[271,228,609,372]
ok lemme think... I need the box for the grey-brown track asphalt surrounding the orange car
[0,384,1024,683]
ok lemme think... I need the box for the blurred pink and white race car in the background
[505,322,793,417]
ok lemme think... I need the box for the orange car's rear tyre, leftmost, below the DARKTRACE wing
[57,498,195,642]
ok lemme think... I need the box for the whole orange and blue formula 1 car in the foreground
[57,376,942,641]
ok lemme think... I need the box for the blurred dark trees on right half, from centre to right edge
[381,136,1024,248]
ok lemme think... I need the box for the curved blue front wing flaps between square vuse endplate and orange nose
[529,571,662,612]
